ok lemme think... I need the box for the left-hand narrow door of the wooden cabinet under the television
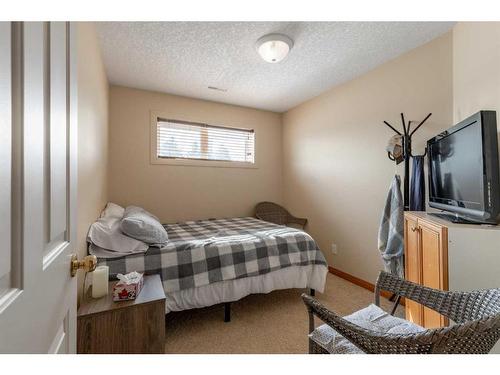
[404,216,423,325]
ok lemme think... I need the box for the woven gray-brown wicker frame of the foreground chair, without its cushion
[302,272,500,354]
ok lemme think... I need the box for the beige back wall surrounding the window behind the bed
[108,86,282,222]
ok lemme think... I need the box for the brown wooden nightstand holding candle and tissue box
[77,275,165,354]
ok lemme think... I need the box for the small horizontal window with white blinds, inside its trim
[156,117,255,164]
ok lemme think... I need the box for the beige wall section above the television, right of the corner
[453,22,500,122]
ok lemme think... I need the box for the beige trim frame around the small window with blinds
[150,111,258,169]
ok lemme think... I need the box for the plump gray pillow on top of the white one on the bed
[120,206,168,247]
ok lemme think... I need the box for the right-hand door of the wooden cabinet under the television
[419,221,448,328]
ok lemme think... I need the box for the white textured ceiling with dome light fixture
[98,22,453,112]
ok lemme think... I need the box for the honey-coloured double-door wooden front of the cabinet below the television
[404,213,448,328]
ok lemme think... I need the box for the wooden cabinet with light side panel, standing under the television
[404,212,500,353]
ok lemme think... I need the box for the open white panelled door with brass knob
[0,22,77,353]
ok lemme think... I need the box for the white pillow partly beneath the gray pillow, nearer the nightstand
[87,216,149,256]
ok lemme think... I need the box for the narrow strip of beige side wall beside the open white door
[77,23,108,300]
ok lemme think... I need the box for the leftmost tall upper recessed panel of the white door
[0,22,24,316]
